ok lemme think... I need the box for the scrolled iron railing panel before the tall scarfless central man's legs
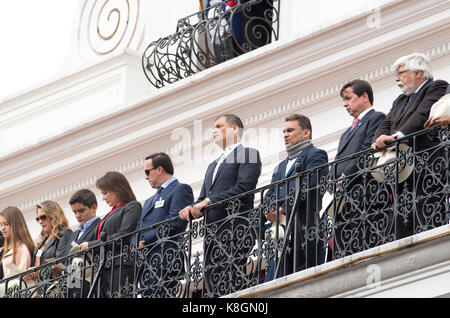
[196,196,263,298]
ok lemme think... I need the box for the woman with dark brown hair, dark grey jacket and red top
[80,171,142,297]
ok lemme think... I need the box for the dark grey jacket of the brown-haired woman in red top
[88,201,142,247]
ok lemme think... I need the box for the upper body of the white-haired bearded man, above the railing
[372,53,448,150]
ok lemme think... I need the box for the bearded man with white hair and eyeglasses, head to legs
[372,53,448,239]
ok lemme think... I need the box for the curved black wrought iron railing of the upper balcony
[142,0,281,88]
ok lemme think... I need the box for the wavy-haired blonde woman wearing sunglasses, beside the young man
[32,201,72,267]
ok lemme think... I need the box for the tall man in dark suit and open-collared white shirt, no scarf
[179,114,261,297]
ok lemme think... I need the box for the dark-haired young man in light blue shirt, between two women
[66,189,100,298]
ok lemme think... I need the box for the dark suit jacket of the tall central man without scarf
[196,145,261,224]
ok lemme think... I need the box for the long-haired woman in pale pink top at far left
[0,206,34,277]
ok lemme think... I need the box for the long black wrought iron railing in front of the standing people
[0,127,450,298]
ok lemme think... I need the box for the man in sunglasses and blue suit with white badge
[136,152,194,297]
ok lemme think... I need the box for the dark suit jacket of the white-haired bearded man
[373,80,448,150]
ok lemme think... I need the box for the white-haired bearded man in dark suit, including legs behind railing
[372,53,448,239]
